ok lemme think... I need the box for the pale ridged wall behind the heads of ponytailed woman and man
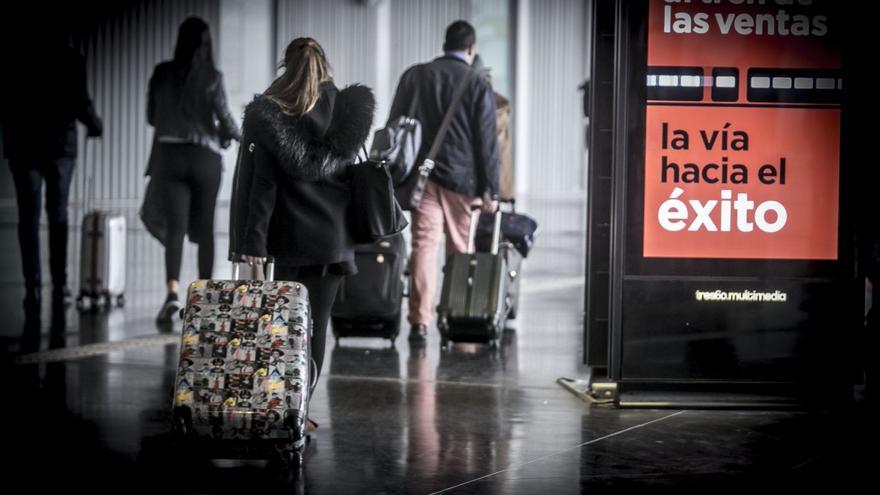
[277,0,513,136]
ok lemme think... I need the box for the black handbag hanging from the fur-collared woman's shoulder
[349,151,409,244]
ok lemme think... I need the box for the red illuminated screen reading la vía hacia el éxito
[643,0,843,260]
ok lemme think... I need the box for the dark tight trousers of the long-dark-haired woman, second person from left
[151,143,223,280]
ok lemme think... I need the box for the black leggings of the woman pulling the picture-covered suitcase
[275,266,342,394]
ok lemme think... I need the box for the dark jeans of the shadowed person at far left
[9,158,75,289]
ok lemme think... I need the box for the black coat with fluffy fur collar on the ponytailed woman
[229,82,375,267]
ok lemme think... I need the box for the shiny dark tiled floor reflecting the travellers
[0,223,878,495]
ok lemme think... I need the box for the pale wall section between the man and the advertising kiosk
[514,0,589,275]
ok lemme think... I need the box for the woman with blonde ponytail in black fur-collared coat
[230,38,375,429]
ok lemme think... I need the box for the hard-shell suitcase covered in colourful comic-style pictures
[172,264,314,463]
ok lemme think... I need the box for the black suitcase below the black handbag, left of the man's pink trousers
[330,235,406,343]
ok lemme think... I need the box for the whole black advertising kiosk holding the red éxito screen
[610,0,864,382]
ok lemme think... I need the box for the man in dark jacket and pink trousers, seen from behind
[389,21,498,345]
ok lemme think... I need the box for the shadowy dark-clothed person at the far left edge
[0,30,102,313]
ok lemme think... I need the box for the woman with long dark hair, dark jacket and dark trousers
[144,17,240,323]
